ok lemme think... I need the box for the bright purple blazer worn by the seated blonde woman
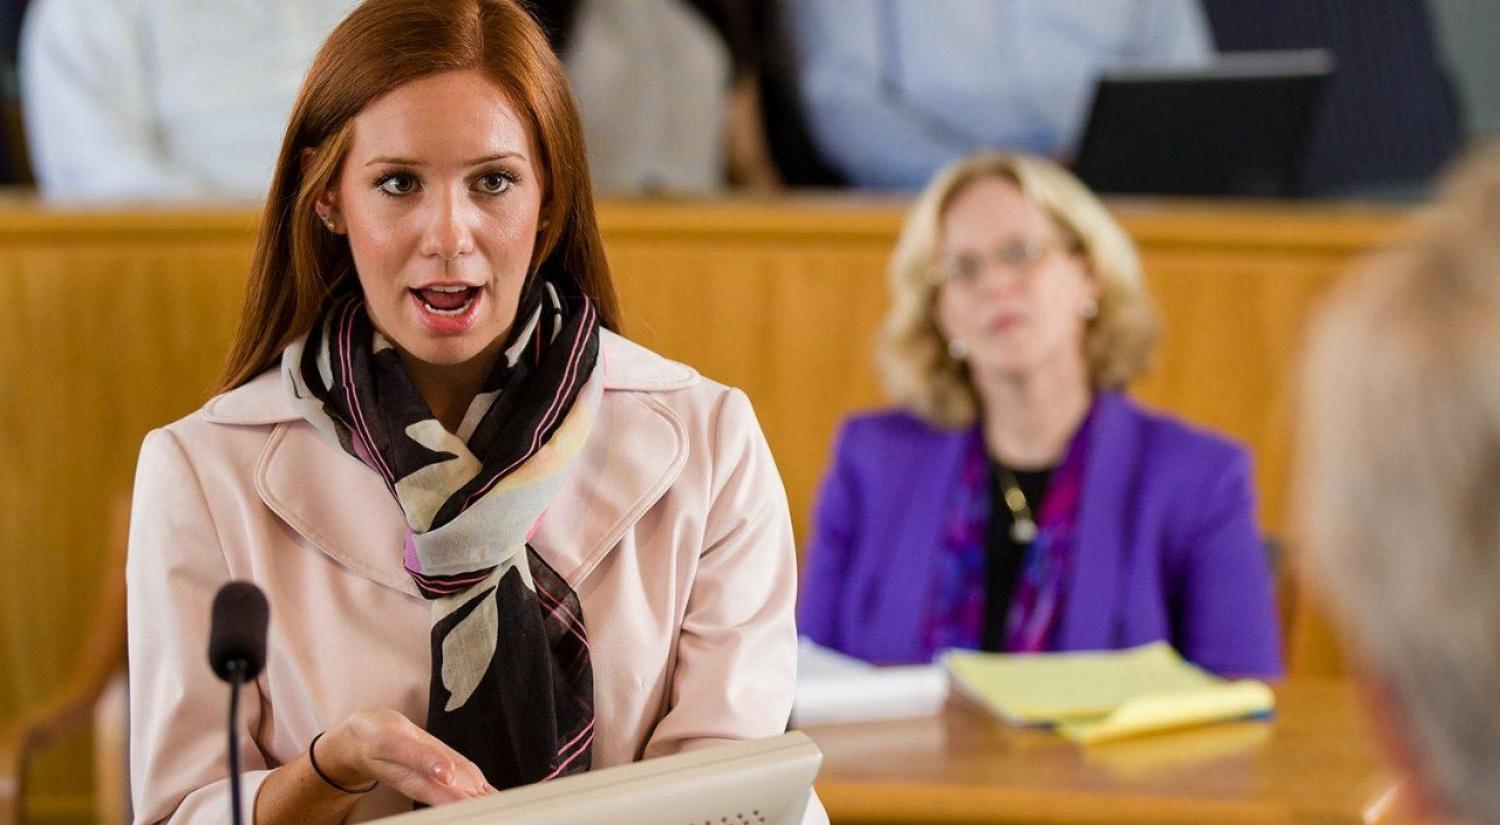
[798,393,1283,677]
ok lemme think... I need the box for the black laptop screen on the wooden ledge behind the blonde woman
[1074,50,1334,197]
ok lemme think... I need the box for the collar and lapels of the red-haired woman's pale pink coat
[203,330,698,597]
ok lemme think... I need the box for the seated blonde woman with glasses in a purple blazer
[798,155,1281,677]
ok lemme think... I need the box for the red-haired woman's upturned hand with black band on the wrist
[315,708,495,806]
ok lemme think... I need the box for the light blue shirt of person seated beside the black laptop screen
[789,0,1214,189]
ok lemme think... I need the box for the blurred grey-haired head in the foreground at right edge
[1298,147,1500,824]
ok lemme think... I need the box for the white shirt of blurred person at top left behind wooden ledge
[21,0,357,200]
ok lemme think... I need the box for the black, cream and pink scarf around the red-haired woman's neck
[282,284,603,789]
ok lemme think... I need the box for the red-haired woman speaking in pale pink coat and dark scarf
[129,0,816,824]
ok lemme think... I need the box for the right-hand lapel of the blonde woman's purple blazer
[1056,393,1140,650]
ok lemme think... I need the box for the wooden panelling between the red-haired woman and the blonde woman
[612,237,885,555]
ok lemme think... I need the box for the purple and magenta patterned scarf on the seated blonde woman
[924,408,1094,656]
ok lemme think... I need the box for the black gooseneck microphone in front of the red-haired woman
[209,582,272,825]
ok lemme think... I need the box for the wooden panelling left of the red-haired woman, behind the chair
[0,215,249,821]
